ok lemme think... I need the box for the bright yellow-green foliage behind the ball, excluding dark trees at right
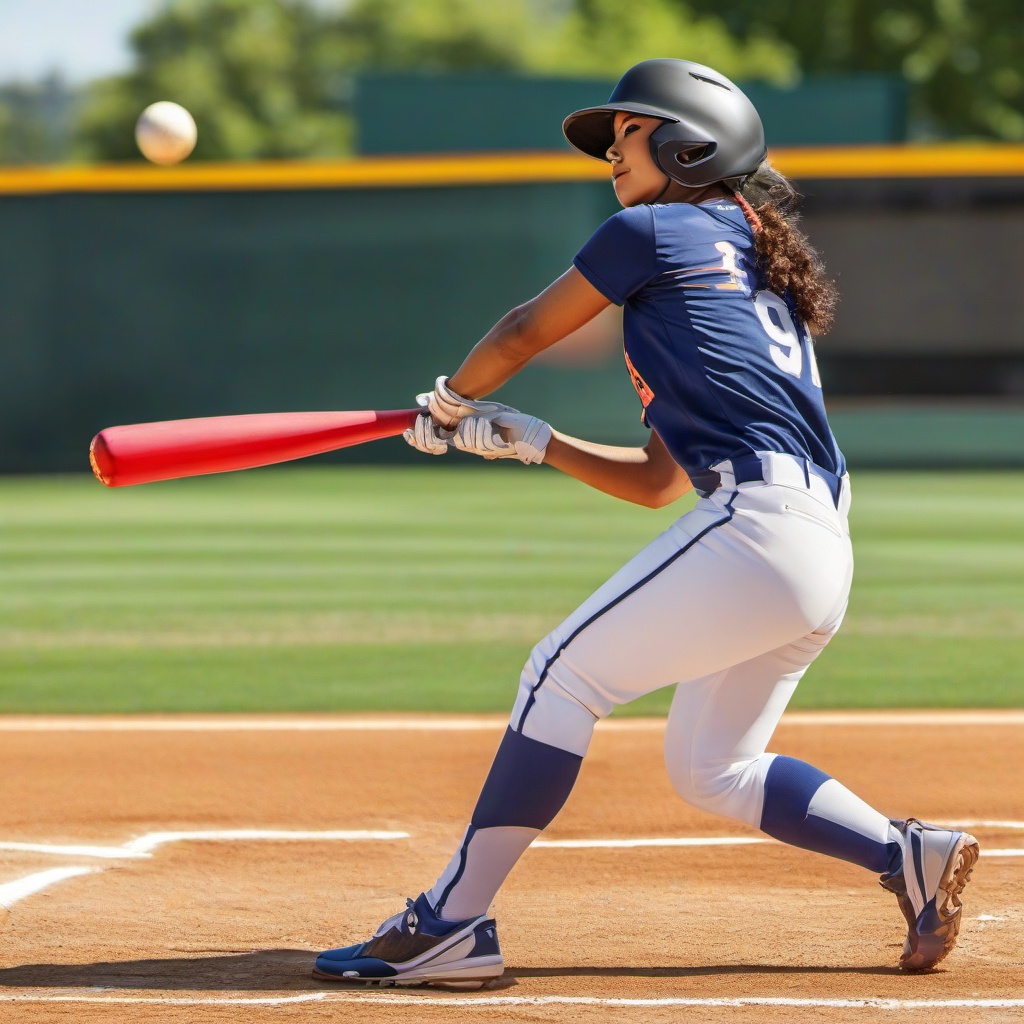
[79,0,796,160]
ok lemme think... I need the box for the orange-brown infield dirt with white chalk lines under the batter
[0,711,1024,1024]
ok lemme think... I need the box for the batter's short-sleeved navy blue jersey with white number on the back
[573,199,846,475]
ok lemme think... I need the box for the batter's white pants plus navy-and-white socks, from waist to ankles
[429,454,902,921]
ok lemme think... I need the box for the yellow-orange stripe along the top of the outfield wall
[0,144,1024,195]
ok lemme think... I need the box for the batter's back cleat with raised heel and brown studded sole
[880,818,978,971]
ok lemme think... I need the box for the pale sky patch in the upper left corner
[0,0,159,83]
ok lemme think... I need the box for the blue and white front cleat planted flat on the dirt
[313,894,505,989]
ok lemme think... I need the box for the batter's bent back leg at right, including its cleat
[665,629,978,971]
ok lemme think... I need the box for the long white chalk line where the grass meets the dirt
[0,709,1024,732]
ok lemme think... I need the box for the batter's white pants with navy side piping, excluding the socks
[511,454,853,826]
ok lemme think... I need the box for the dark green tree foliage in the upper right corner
[672,0,1024,140]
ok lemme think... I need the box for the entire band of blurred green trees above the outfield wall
[72,0,1024,160]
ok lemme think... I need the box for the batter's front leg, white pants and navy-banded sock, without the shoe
[419,477,851,920]
